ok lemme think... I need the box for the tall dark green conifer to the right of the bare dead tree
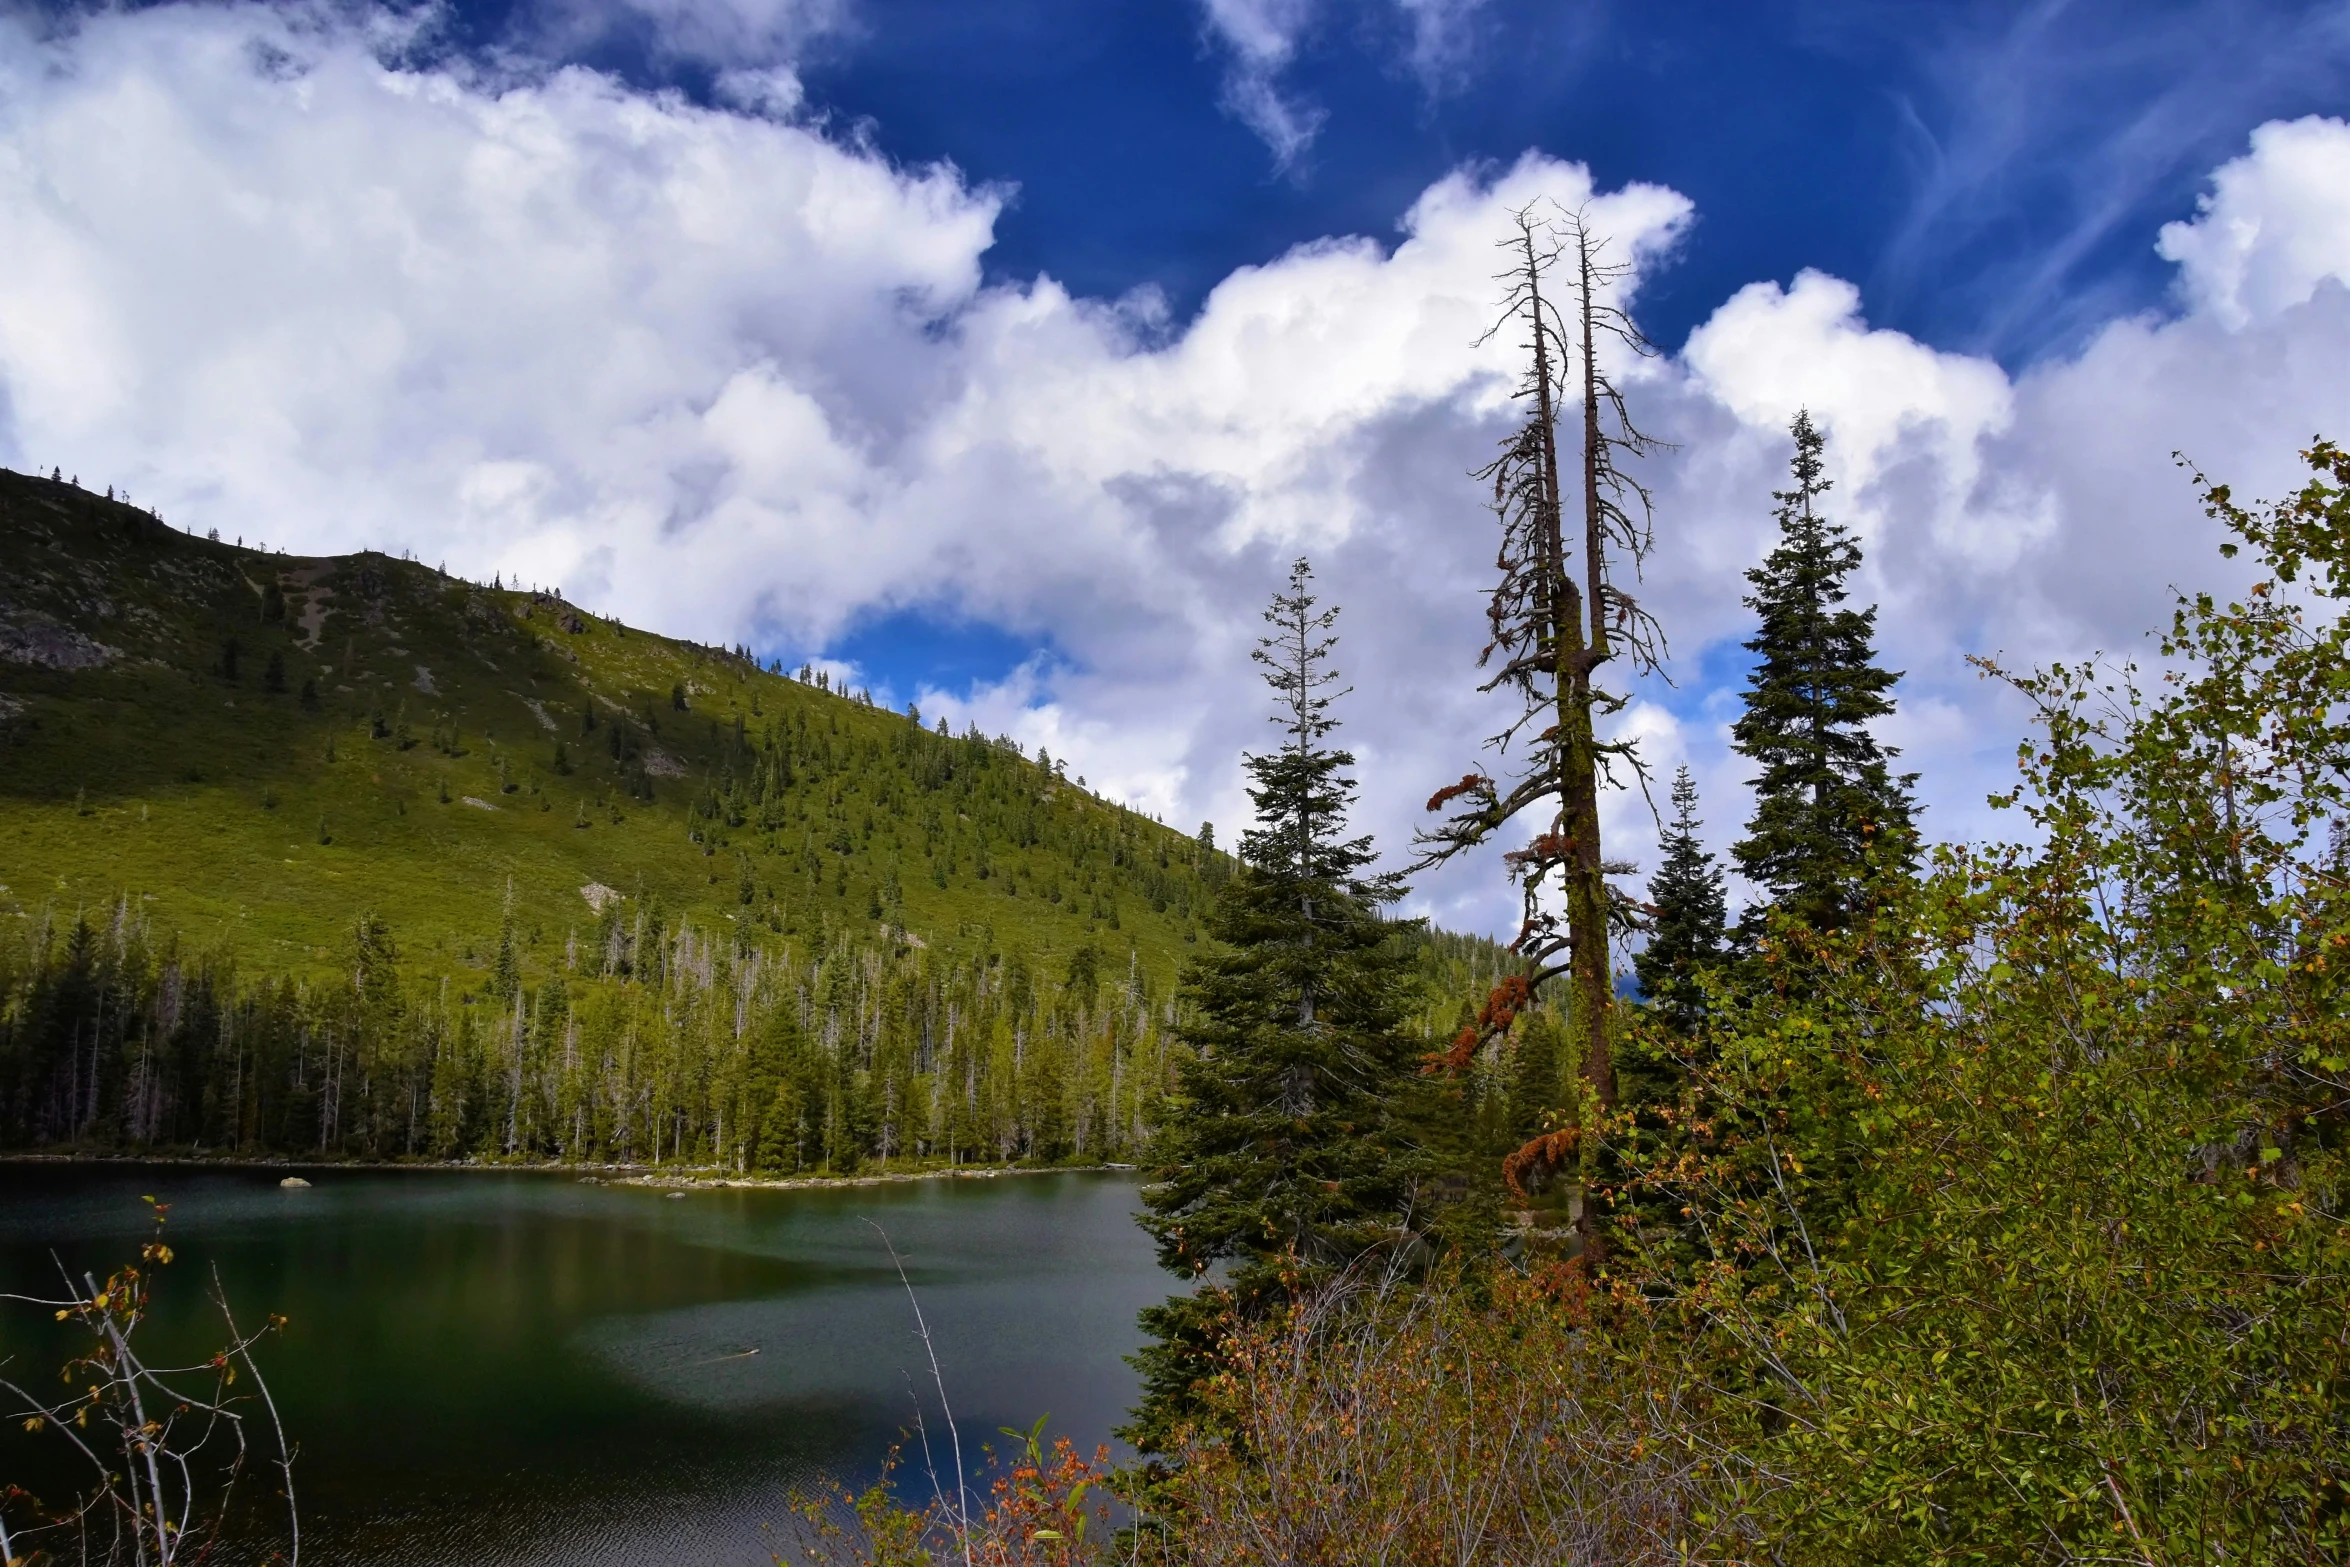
[1730,411,1918,930]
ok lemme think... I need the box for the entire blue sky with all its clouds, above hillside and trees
[0,0,2350,930]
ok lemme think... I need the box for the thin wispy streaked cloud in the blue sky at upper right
[1870,0,2350,357]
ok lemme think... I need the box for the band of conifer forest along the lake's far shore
[0,900,1499,1175]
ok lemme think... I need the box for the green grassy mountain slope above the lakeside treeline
[0,470,1213,977]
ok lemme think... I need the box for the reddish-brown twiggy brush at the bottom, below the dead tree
[1165,1262,1751,1567]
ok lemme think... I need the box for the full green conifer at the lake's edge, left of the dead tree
[1126,559,1412,1452]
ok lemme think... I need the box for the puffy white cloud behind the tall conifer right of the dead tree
[1666,120,2350,883]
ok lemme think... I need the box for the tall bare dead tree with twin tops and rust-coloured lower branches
[1419,207,1664,1243]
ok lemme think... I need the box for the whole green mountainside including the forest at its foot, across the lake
[0,470,1504,1175]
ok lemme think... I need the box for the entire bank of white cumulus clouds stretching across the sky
[0,7,2350,944]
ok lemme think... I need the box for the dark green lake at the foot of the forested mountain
[0,1165,1170,1567]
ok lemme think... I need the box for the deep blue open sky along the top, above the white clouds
[491,0,2350,366]
